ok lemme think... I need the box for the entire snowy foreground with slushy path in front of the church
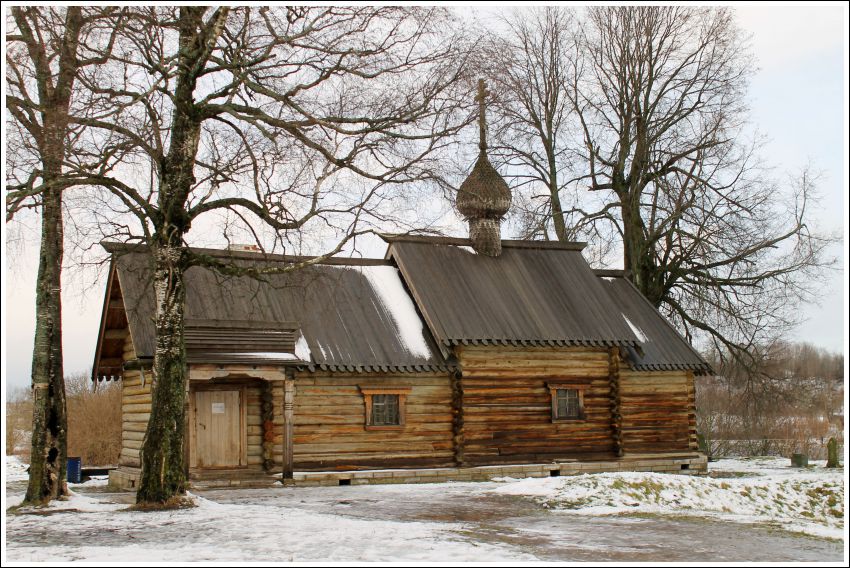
[4,458,844,562]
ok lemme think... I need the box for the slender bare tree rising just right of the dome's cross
[482,7,576,241]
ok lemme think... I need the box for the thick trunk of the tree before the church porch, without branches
[136,8,214,503]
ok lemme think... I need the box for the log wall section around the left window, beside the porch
[293,373,454,471]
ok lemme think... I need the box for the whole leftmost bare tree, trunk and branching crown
[6,6,125,504]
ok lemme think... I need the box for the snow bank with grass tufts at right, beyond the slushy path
[493,458,844,538]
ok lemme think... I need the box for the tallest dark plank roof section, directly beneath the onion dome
[385,237,639,347]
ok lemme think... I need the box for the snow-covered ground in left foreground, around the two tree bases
[5,458,535,562]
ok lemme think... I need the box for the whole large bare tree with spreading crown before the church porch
[69,7,469,503]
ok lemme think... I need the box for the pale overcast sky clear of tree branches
[3,4,848,389]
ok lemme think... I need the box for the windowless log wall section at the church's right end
[620,365,697,454]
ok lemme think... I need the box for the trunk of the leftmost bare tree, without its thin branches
[12,7,83,504]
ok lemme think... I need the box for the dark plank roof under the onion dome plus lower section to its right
[384,235,711,373]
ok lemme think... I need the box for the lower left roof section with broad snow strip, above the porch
[101,245,446,372]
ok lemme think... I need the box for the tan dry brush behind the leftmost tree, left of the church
[6,374,121,465]
